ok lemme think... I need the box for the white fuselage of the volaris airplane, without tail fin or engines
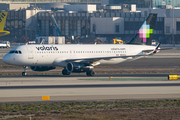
[3,44,155,67]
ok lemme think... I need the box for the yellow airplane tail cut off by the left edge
[0,11,10,37]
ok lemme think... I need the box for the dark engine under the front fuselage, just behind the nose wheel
[30,66,56,71]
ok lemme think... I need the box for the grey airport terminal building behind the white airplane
[0,0,180,43]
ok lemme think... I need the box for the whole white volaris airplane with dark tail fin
[2,14,161,76]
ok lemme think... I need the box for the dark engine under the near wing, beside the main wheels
[66,62,93,72]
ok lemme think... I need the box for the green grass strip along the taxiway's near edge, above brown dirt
[0,99,180,115]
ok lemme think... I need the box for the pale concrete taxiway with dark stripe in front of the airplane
[0,76,180,102]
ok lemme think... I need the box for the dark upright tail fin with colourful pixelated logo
[128,13,157,45]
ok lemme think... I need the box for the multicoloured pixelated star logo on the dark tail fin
[138,21,153,42]
